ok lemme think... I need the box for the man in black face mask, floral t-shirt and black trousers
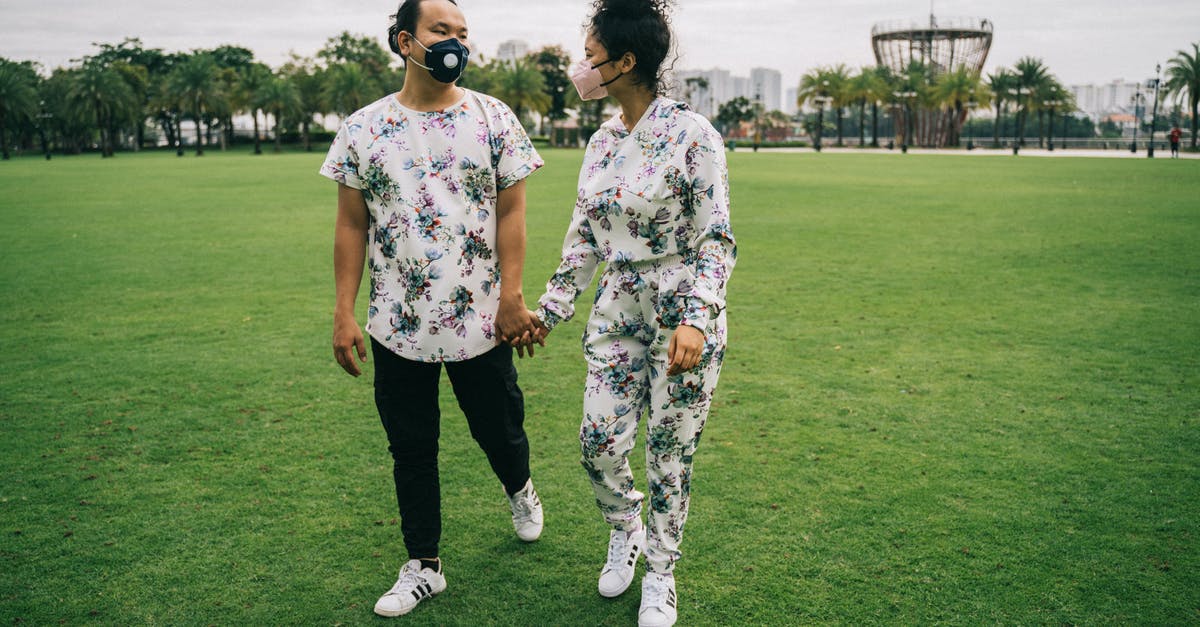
[320,0,542,616]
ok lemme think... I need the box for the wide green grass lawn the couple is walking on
[0,151,1200,625]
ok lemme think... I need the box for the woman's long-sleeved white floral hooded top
[538,97,737,332]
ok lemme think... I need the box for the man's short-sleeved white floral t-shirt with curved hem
[320,89,542,363]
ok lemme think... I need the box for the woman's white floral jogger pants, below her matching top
[580,257,726,574]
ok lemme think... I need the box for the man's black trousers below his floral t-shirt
[371,339,529,560]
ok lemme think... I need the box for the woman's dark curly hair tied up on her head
[584,0,674,95]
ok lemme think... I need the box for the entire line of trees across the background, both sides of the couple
[0,32,1200,159]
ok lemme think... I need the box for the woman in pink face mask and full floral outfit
[535,0,737,626]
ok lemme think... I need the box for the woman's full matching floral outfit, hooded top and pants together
[538,98,737,573]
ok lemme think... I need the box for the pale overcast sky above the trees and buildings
[0,0,1200,88]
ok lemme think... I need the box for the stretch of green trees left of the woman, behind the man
[0,32,583,159]
